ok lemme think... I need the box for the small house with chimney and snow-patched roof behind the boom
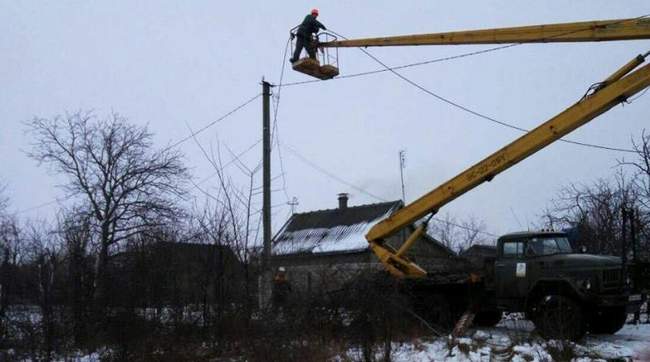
[270,194,457,293]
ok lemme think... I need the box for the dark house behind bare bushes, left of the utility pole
[109,241,244,306]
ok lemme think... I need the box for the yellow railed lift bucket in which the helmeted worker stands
[291,28,339,80]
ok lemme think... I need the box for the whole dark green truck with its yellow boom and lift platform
[293,17,650,339]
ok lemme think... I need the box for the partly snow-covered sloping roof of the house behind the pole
[273,201,402,255]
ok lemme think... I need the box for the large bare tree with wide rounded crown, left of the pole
[26,112,188,304]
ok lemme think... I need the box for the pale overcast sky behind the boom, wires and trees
[0,0,650,239]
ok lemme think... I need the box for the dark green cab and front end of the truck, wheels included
[493,231,645,339]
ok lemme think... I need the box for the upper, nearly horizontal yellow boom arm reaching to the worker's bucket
[318,17,650,48]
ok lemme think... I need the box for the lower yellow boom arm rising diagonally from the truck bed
[366,54,650,277]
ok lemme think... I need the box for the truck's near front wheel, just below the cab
[533,295,586,341]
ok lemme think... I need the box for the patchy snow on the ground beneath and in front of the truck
[342,320,650,362]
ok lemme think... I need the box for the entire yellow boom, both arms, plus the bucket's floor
[293,16,650,277]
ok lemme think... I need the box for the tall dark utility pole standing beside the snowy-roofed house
[260,78,272,307]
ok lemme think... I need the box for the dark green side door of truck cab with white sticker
[495,239,527,302]
